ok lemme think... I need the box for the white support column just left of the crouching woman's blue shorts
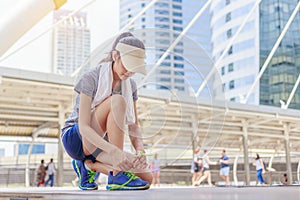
[56,105,65,186]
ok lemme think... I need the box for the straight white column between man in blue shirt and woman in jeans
[243,121,250,186]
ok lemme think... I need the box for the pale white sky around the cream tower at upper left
[0,0,119,72]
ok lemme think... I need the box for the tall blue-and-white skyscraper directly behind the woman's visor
[120,0,211,96]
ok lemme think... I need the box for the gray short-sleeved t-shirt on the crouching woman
[60,62,138,137]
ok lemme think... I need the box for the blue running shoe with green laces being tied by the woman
[106,172,150,190]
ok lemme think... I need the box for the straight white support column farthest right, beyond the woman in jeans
[283,123,293,184]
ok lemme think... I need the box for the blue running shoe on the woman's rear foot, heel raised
[72,160,98,190]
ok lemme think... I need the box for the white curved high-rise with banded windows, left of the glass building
[210,0,259,104]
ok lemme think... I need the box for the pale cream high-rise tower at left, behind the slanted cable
[52,10,90,76]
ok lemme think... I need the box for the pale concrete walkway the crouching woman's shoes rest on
[0,186,300,200]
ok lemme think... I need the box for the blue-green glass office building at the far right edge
[259,0,300,109]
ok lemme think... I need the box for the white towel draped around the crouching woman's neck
[92,62,135,125]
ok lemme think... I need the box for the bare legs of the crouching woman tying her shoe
[80,95,152,184]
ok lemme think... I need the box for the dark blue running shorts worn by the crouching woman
[62,124,108,162]
